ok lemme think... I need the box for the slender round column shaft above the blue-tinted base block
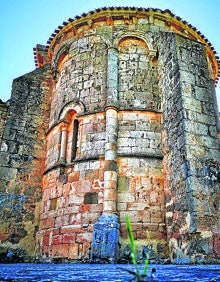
[103,47,118,213]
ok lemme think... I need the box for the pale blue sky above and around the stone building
[0,0,220,110]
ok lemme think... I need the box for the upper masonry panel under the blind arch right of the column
[118,38,160,110]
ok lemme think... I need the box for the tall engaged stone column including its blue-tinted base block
[91,48,119,263]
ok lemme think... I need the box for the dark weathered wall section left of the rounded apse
[0,66,52,255]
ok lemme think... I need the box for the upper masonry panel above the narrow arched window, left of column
[50,35,107,124]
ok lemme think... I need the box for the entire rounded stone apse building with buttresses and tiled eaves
[0,7,220,263]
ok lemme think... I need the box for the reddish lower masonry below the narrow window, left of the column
[37,156,104,261]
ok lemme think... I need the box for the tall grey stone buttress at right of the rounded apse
[159,34,219,262]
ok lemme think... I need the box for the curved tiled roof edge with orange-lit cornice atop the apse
[34,7,220,83]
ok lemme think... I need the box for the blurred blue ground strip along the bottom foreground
[0,263,220,282]
